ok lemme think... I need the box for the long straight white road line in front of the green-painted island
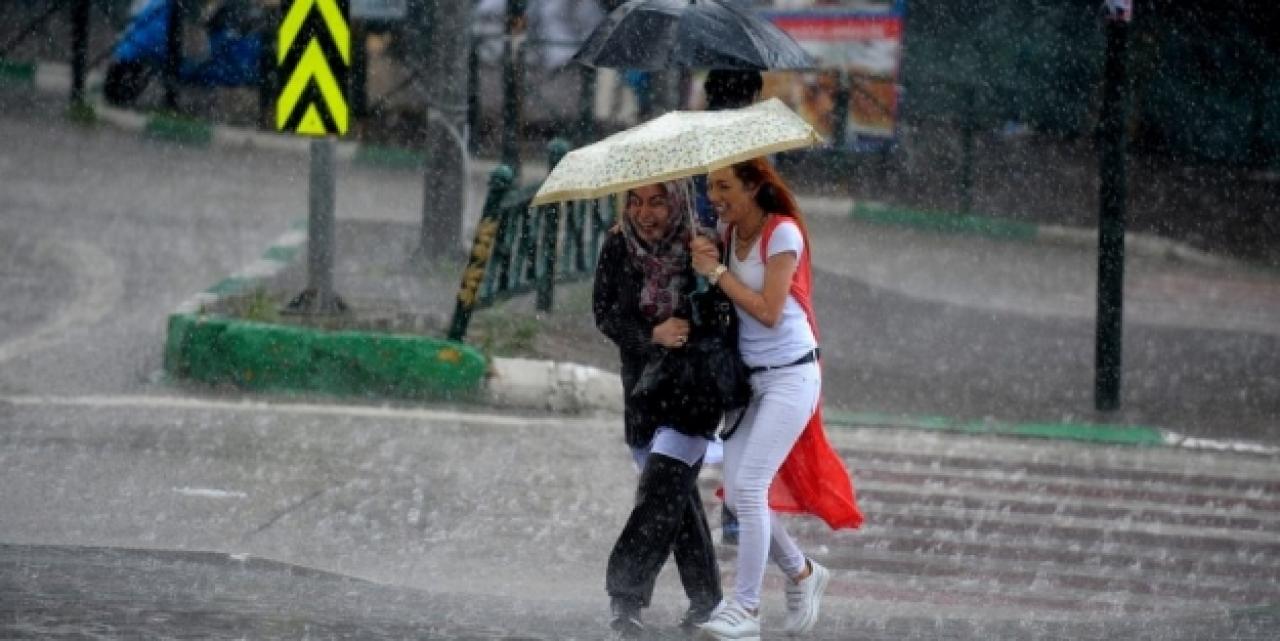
[0,395,593,427]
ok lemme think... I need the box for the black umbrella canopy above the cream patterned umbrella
[573,0,815,70]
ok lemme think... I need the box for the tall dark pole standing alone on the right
[1093,0,1133,411]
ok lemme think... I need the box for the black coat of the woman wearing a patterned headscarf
[591,233,722,448]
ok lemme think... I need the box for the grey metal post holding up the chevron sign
[285,137,347,315]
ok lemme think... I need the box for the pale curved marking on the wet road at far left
[0,241,124,362]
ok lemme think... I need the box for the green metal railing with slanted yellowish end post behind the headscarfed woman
[449,138,617,340]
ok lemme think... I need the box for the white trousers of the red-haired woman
[724,363,822,609]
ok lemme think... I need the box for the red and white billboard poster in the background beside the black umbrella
[756,0,906,150]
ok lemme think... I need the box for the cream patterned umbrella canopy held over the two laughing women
[532,99,822,205]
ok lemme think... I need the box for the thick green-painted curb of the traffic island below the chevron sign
[165,313,486,399]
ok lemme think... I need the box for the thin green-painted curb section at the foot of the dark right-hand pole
[823,411,1165,447]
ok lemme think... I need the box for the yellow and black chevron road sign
[275,0,351,136]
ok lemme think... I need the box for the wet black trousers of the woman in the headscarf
[605,453,722,609]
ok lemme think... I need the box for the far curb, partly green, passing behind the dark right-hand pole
[850,202,1239,267]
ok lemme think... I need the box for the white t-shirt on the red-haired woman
[728,220,818,367]
